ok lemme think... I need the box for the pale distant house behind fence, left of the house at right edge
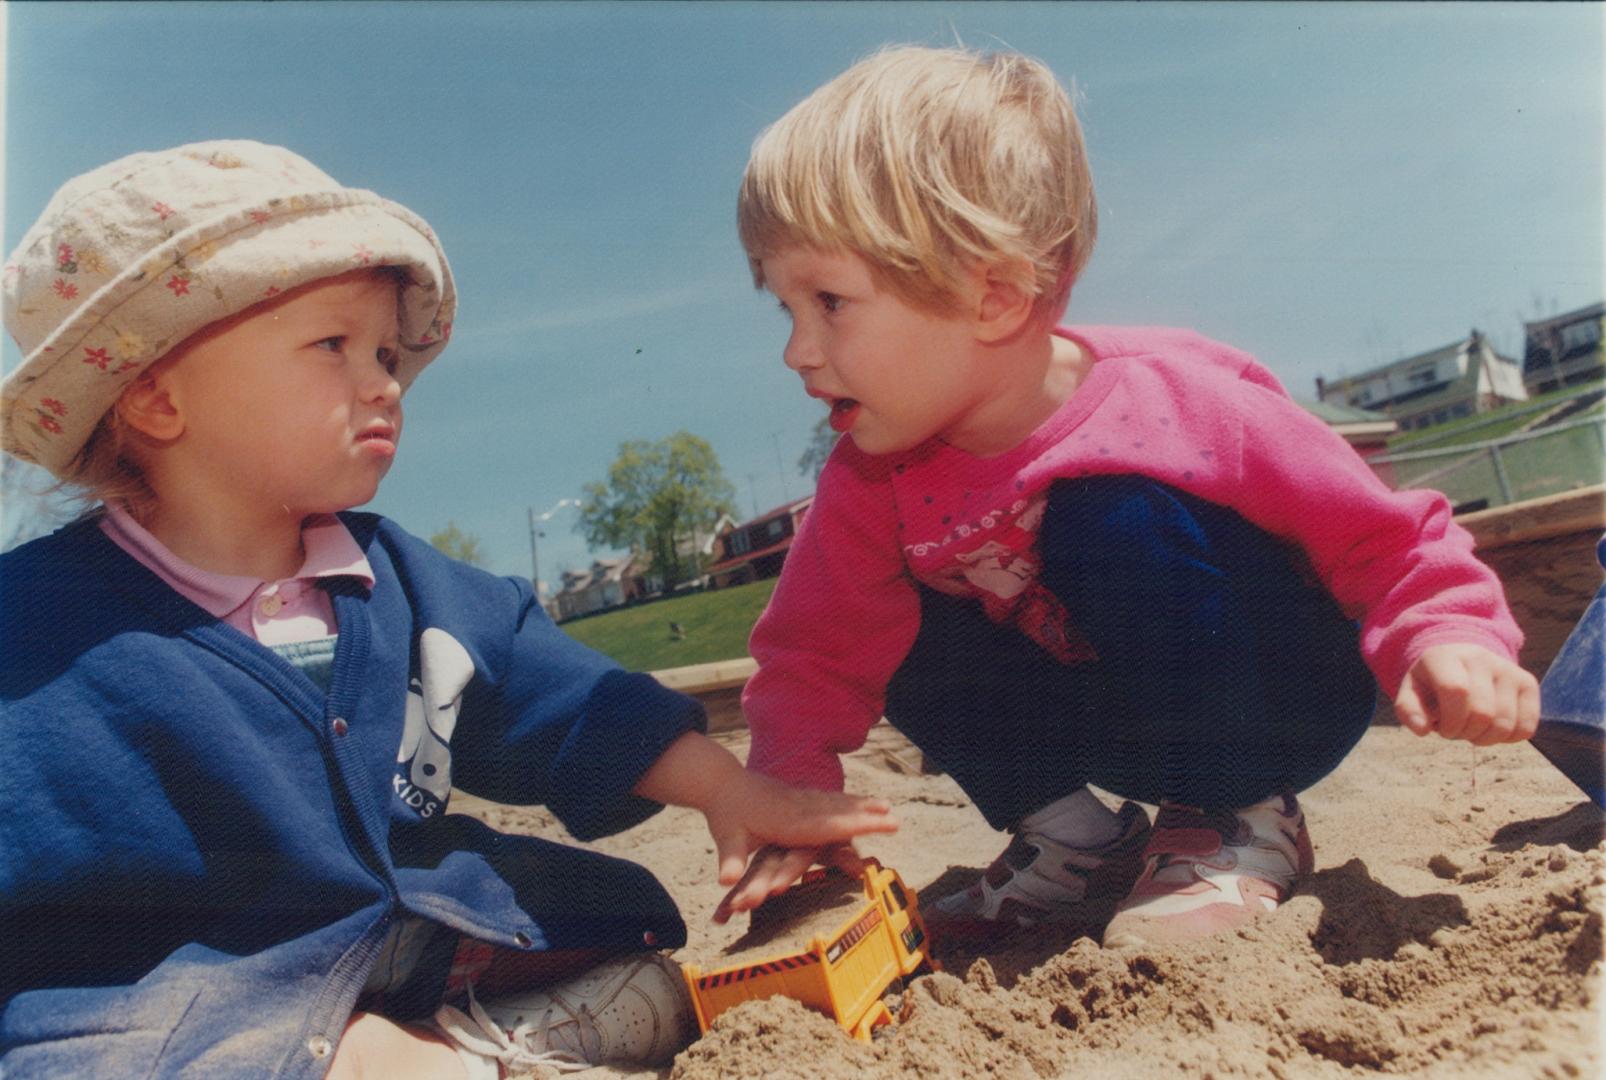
[1315,329,1527,431]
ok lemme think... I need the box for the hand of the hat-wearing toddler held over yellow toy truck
[703,770,898,923]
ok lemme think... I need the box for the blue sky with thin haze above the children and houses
[0,0,1606,591]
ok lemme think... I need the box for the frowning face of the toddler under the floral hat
[142,272,402,521]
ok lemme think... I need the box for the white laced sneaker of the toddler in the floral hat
[434,953,697,1070]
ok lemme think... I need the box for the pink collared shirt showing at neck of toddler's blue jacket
[101,505,374,644]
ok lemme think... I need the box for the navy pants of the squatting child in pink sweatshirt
[887,476,1376,829]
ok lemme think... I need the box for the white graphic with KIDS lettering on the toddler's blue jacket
[392,627,474,818]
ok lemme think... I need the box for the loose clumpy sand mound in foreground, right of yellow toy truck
[684,852,1603,1080]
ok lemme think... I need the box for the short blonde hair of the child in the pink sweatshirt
[737,47,1099,317]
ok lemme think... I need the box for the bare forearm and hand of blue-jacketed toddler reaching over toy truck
[634,731,898,900]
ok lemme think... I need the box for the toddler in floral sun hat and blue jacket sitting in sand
[0,141,895,1077]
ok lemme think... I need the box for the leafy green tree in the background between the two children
[575,431,736,588]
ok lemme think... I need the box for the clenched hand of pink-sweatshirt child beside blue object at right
[1394,644,1539,746]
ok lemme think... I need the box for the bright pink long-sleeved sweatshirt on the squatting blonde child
[742,326,1522,788]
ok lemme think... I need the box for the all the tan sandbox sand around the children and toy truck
[453,725,1606,1080]
